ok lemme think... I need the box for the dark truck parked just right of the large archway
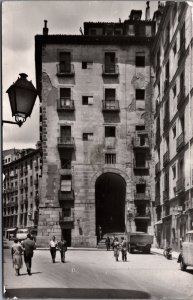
[128,232,153,253]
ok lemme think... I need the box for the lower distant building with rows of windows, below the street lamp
[2,144,41,238]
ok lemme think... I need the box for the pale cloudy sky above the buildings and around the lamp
[2,0,158,150]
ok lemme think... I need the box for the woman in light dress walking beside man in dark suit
[11,239,24,276]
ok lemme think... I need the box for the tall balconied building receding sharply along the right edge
[151,1,193,249]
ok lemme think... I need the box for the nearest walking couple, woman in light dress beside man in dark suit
[11,233,36,276]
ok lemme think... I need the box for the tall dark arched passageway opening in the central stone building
[95,173,126,234]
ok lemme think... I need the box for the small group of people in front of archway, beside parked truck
[105,236,127,261]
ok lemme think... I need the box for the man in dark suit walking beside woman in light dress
[22,233,36,275]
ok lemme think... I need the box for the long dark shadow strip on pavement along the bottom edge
[5,288,151,299]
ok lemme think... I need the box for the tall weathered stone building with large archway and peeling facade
[35,4,155,247]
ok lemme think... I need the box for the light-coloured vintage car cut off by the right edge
[180,230,193,271]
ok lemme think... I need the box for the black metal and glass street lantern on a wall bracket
[2,73,38,127]
